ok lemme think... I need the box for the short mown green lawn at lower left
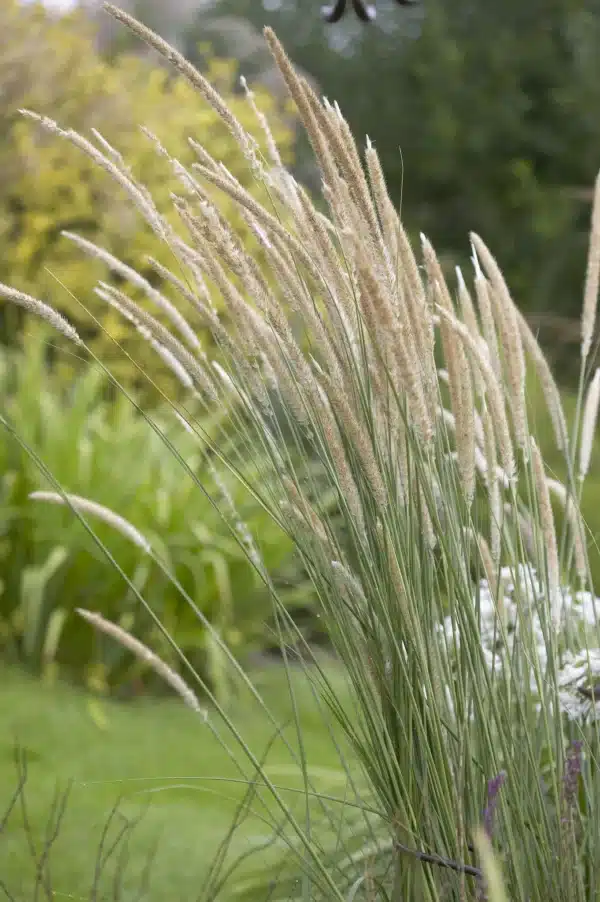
[0,665,352,902]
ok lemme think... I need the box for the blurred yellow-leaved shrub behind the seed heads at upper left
[0,0,293,396]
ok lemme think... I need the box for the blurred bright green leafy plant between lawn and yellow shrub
[0,330,310,704]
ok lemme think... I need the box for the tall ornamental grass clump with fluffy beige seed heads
[1,5,600,902]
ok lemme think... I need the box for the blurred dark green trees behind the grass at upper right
[186,0,600,368]
